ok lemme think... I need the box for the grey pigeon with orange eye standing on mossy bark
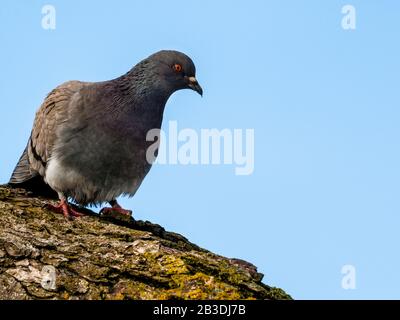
[9,50,203,219]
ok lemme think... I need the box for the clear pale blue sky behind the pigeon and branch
[0,0,400,299]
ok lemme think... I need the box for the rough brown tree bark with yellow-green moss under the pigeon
[0,186,290,299]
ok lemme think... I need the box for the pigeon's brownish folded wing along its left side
[9,81,85,184]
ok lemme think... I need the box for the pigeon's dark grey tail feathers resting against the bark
[8,148,58,199]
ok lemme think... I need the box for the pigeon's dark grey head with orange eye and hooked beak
[147,50,203,96]
